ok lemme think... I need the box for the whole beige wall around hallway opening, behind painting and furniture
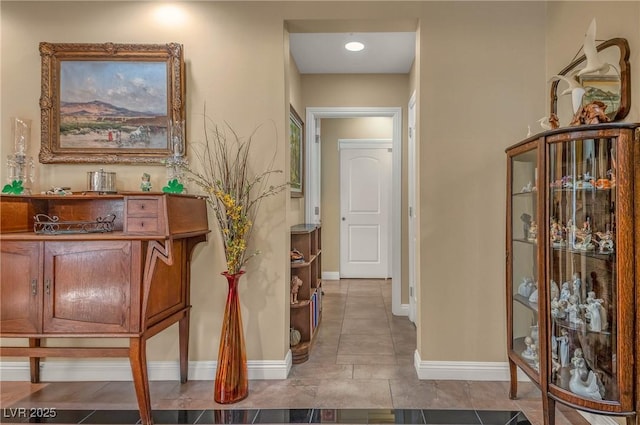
[0,0,640,368]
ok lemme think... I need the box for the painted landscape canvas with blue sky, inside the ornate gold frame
[60,61,168,149]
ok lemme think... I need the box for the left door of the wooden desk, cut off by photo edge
[0,242,42,334]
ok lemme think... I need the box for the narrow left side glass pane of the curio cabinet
[507,145,540,382]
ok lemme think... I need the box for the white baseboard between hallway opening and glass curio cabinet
[413,350,529,382]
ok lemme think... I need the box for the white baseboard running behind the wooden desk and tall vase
[0,350,292,382]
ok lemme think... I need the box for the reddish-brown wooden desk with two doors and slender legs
[0,192,209,424]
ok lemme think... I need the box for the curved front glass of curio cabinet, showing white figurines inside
[547,138,620,401]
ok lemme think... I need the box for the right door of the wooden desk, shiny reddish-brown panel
[44,241,136,333]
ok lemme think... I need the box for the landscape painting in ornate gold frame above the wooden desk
[40,42,185,164]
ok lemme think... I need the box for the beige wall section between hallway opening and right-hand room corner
[418,2,546,361]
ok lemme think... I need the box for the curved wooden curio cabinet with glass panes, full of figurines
[506,123,640,425]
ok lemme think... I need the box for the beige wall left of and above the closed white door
[320,117,393,272]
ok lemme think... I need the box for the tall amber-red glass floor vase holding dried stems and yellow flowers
[213,271,249,404]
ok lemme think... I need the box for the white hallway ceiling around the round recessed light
[289,32,416,74]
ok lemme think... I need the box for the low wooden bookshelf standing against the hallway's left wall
[290,224,322,363]
